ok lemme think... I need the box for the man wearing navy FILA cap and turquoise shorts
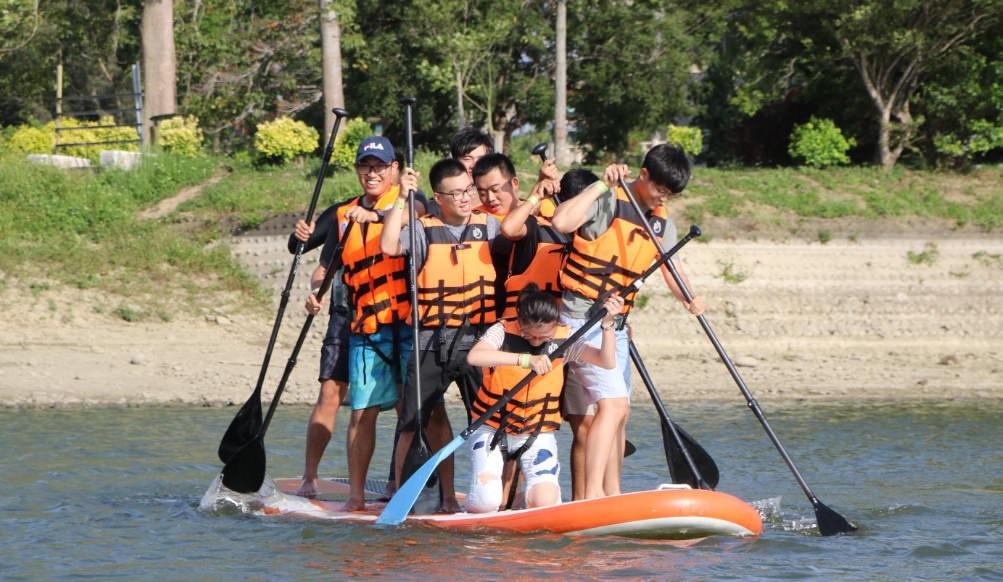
[294,135,425,511]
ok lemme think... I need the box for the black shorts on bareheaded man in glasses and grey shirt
[399,332,483,432]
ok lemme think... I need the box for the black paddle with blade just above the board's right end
[625,339,720,489]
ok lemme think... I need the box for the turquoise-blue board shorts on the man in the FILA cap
[348,323,412,410]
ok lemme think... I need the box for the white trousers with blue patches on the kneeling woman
[463,425,561,514]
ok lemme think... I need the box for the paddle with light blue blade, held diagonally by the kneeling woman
[376,225,700,525]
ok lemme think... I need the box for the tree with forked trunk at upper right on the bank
[718,0,1003,169]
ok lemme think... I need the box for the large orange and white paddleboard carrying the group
[263,479,762,540]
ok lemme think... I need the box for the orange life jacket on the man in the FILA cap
[338,186,411,334]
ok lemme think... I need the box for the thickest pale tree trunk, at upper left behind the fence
[141,0,178,146]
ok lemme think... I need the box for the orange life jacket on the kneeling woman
[470,319,569,434]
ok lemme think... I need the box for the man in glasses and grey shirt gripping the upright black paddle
[380,159,500,512]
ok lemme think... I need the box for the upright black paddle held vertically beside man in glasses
[398,95,429,485]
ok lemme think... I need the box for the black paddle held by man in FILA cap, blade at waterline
[223,223,355,493]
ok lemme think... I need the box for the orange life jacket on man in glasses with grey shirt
[417,211,495,327]
